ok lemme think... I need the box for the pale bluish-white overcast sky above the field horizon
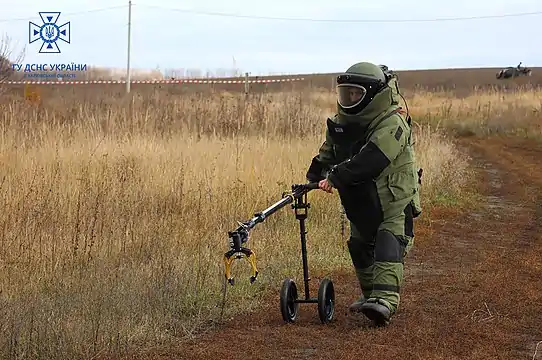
[0,0,542,75]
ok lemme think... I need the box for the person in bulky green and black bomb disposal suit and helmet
[306,62,422,326]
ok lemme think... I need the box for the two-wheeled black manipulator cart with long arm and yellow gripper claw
[224,183,335,324]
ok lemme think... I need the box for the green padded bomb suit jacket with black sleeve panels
[307,78,422,221]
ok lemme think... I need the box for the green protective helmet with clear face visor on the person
[337,62,387,114]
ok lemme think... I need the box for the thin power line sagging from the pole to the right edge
[139,4,542,23]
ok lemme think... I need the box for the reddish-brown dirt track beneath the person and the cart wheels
[130,139,542,360]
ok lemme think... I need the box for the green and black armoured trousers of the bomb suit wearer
[339,177,414,314]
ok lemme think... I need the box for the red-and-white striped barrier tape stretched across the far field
[4,77,305,85]
